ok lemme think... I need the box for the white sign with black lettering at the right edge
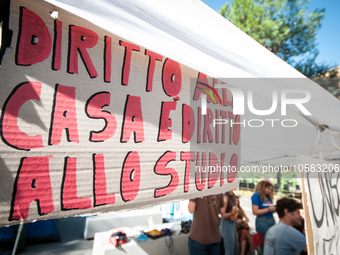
[296,155,340,255]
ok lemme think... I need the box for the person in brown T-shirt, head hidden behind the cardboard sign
[188,194,224,255]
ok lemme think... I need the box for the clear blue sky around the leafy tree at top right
[202,0,340,66]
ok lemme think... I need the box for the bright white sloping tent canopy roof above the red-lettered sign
[46,0,340,131]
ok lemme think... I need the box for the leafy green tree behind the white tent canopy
[219,0,333,77]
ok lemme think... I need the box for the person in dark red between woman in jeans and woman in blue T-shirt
[236,197,250,255]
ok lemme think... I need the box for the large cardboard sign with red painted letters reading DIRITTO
[0,0,240,226]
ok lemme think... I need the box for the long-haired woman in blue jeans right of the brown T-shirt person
[220,190,239,255]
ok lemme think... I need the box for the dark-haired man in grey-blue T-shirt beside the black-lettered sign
[264,198,307,255]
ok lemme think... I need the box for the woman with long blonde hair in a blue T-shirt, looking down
[251,179,276,253]
